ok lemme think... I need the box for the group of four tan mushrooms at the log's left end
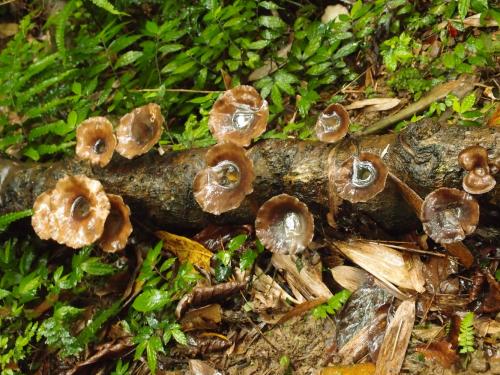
[31,103,164,252]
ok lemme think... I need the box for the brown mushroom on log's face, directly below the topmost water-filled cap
[193,143,255,215]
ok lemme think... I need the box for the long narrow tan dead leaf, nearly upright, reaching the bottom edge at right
[375,301,415,375]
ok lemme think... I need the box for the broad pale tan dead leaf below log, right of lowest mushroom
[334,241,425,293]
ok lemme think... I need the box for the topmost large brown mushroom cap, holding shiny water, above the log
[208,86,269,147]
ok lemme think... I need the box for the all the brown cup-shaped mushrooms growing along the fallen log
[32,85,500,254]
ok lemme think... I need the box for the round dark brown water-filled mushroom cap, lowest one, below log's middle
[255,194,314,254]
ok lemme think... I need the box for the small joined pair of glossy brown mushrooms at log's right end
[458,146,496,194]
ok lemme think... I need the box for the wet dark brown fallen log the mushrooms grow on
[0,120,500,233]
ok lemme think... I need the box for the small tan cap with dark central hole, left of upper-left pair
[76,117,116,167]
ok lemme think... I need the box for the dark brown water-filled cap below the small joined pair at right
[420,188,479,244]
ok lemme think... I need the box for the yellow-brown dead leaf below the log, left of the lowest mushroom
[155,230,213,271]
